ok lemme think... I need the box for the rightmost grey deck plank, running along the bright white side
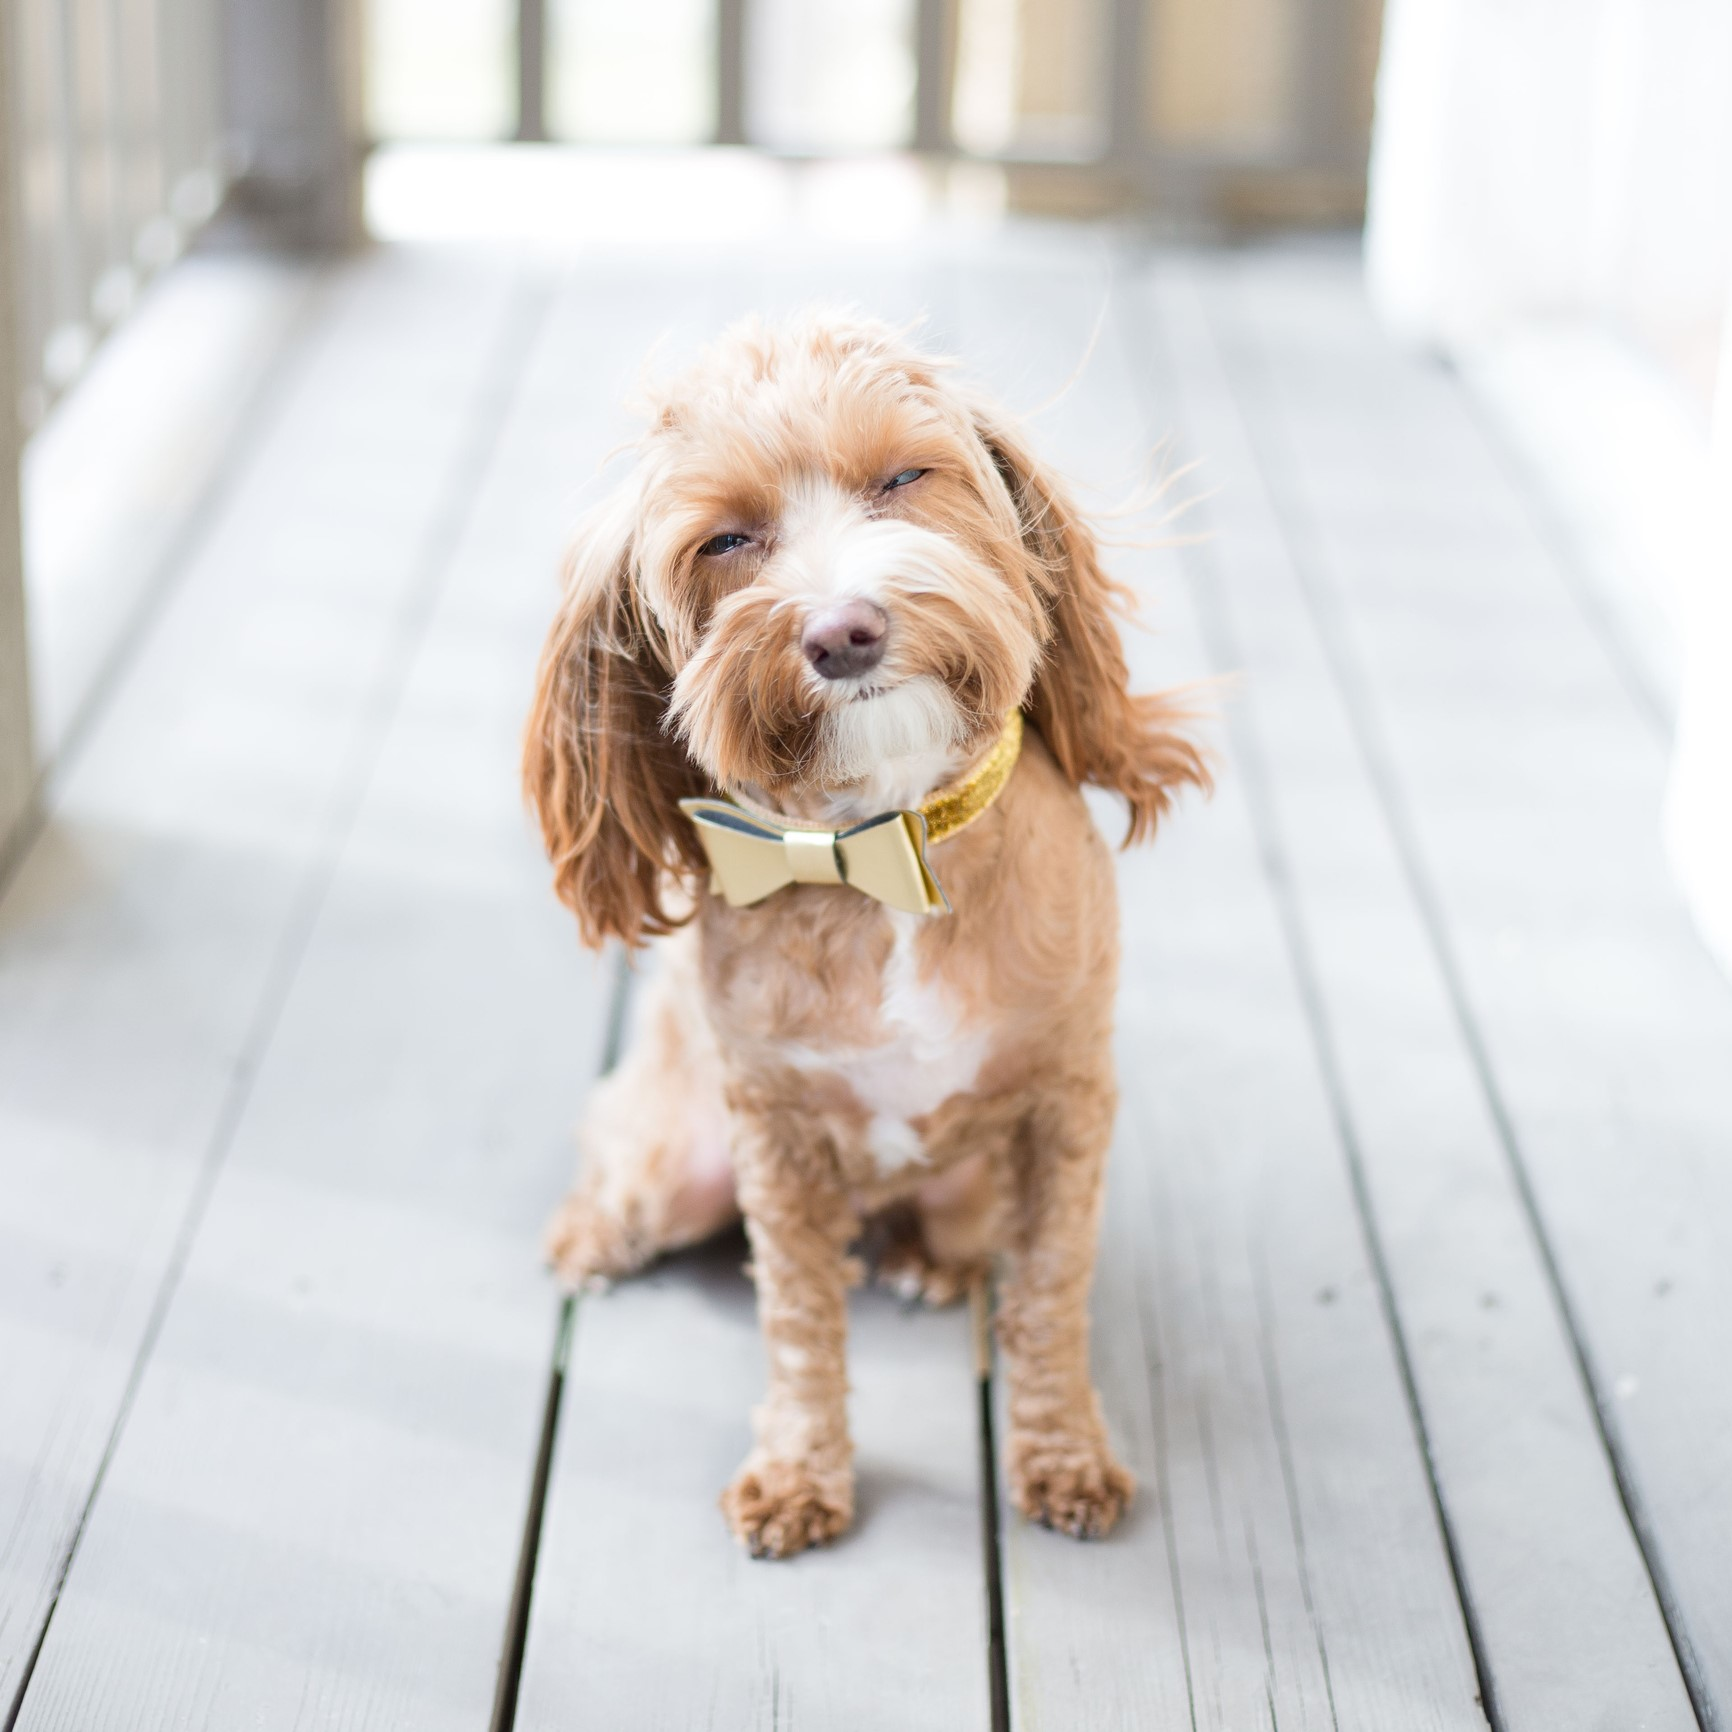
[1221,258,1732,1723]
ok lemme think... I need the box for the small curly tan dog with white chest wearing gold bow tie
[525,312,1209,1557]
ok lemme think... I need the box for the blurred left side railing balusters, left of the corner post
[9,0,227,426]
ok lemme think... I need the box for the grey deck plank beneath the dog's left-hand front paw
[518,248,989,1732]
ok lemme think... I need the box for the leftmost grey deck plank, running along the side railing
[0,260,529,1704]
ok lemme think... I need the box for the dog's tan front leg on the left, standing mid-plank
[722,1115,859,1557]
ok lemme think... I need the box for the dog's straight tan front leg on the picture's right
[998,1077,1133,1540]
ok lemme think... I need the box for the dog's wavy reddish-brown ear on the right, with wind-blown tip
[975,409,1211,843]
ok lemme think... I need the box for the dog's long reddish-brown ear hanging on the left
[523,490,703,946]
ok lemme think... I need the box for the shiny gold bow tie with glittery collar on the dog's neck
[679,710,1022,914]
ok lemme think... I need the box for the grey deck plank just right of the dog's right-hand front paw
[965,247,1483,1732]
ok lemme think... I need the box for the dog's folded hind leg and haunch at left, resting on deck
[547,934,740,1287]
